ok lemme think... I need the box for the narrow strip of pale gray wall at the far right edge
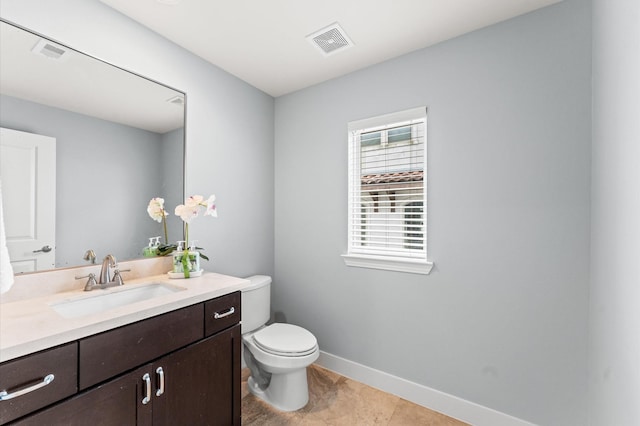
[589,0,640,426]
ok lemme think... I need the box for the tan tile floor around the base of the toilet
[242,364,466,426]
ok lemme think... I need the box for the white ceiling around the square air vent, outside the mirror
[101,0,560,97]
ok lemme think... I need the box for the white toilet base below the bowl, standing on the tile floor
[247,367,309,411]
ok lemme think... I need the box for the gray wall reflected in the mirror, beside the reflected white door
[0,96,166,267]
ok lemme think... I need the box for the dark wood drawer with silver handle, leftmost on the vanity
[0,342,78,424]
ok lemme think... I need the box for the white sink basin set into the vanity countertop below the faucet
[50,283,184,318]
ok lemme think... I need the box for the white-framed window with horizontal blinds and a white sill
[343,107,433,274]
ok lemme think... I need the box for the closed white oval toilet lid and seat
[253,323,318,356]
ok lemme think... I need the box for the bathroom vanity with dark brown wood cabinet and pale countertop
[0,268,246,425]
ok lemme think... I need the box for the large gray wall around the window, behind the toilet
[272,0,591,425]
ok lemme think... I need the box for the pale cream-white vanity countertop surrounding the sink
[0,272,249,362]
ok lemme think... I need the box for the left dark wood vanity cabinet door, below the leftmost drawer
[15,367,151,426]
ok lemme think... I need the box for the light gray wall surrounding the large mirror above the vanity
[0,0,274,276]
